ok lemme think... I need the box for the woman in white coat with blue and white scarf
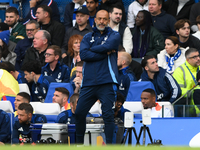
[157,36,189,74]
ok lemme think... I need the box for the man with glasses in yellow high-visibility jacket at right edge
[173,48,200,104]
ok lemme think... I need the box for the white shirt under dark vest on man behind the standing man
[113,24,133,54]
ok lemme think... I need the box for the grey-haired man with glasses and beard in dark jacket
[14,20,40,70]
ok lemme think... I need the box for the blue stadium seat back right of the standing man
[126,81,155,101]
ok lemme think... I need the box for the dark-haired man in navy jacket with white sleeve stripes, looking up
[141,55,181,103]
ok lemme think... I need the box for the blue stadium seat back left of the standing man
[44,82,74,103]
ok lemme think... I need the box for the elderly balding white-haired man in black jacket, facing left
[23,30,51,66]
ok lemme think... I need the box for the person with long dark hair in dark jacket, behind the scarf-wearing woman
[131,10,164,58]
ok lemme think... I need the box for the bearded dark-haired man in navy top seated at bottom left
[12,103,33,144]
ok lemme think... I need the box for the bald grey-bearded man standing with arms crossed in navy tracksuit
[75,10,121,144]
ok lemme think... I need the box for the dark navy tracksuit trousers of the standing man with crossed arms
[75,83,117,144]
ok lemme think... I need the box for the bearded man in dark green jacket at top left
[5,7,26,43]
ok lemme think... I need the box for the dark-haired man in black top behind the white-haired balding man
[36,5,65,46]
